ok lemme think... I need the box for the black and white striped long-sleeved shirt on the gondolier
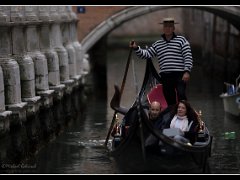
[136,34,193,72]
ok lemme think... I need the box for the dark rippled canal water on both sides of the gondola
[5,49,240,174]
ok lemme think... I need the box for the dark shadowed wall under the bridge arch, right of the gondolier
[184,9,240,84]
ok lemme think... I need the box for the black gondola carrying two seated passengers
[109,59,212,174]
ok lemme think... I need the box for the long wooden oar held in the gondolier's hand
[104,41,134,146]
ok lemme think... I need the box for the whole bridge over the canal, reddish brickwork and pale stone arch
[74,6,240,52]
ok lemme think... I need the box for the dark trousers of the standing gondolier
[160,72,187,105]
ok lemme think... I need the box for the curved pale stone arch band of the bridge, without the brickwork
[82,6,240,52]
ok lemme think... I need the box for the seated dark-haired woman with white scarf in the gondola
[161,100,200,144]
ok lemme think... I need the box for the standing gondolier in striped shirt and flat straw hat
[129,18,193,105]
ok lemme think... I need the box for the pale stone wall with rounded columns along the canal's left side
[0,6,89,134]
